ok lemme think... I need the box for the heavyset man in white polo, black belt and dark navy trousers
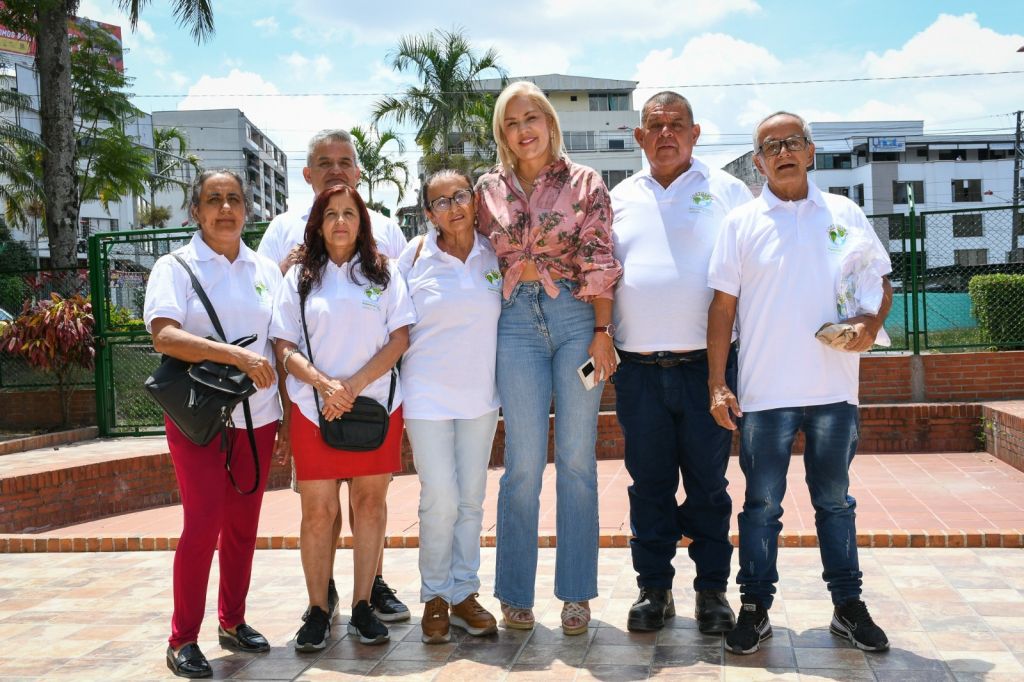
[611,91,751,634]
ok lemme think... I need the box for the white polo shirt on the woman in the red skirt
[270,256,416,424]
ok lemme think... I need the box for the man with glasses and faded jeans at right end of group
[708,112,892,653]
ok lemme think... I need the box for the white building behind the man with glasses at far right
[724,121,1024,268]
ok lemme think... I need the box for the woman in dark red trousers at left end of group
[143,170,284,677]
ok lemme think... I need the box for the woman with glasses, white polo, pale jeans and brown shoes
[398,170,502,644]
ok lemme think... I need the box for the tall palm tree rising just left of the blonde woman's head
[373,29,506,165]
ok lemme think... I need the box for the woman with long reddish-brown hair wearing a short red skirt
[270,185,416,651]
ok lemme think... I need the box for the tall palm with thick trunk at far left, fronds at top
[0,0,213,267]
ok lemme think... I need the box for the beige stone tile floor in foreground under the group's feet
[0,549,1024,682]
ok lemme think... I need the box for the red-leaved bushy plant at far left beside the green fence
[0,293,96,426]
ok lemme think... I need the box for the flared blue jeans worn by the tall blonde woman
[495,281,604,608]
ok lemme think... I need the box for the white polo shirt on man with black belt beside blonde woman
[611,159,752,352]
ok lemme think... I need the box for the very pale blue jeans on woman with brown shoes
[406,410,498,604]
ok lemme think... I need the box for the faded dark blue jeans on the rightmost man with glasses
[736,402,863,608]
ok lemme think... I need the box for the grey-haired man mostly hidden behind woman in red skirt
[256,129,409,622]
